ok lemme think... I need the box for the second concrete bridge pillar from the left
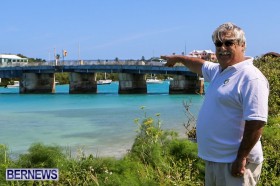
[69,72,97,94]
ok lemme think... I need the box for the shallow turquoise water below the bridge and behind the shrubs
[0,82,203,157]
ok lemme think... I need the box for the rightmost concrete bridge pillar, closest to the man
[169,75,204,94]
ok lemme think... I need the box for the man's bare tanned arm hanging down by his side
[231,120,265,176]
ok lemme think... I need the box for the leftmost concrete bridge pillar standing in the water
[19,73,55,94]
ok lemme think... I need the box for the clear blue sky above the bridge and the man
[0,0,280,60]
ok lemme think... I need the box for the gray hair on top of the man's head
[212,22,246,45]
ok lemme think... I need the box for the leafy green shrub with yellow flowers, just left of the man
[128,107,204,185]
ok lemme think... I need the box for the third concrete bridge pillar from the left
[119,73,147,94]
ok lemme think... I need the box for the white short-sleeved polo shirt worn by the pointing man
[197,58,269,163]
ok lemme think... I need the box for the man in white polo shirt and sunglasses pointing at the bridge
[162,23,269,186]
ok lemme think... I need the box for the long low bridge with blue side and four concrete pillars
[0,61,204,94]
